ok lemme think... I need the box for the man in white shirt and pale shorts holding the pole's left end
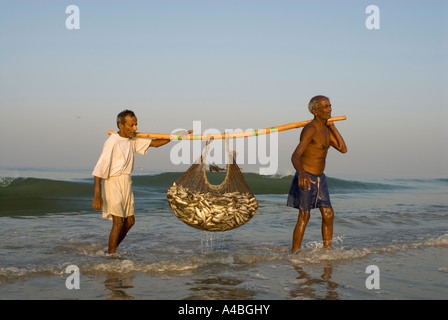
[92,110,170,253]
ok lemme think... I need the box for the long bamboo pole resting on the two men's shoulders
[107,116,347,140]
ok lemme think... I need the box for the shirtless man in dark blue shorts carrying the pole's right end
[287,96,347,252]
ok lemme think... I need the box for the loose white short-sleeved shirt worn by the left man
[92,133,152,179]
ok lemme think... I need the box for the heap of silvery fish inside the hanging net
[167,183,258,231]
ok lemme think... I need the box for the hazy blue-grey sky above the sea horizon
[0,0,448,178]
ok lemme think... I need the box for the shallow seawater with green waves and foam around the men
[0,169,448,300]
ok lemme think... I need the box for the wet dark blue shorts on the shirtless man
[286,172,331,211]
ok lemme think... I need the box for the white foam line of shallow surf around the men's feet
[0,234,448,280]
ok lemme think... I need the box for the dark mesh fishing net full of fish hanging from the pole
[167,138,258,231]
